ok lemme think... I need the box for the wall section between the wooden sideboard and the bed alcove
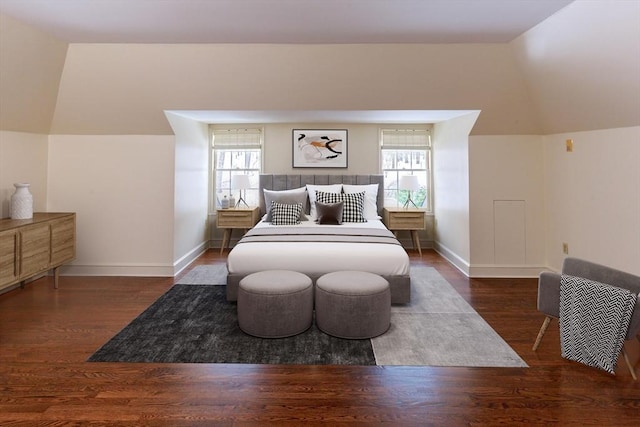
[47,135,175,276]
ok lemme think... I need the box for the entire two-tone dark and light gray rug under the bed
[88,265,527,367]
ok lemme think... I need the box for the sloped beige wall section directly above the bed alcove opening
[52,44,539,135]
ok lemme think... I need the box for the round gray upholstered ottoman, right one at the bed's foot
[316,271,391,339]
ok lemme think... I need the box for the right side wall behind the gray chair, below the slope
[544,126,640,275]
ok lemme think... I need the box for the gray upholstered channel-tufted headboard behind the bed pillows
[258,174,384,216]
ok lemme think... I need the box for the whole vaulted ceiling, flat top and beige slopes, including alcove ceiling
[0,0,640,134]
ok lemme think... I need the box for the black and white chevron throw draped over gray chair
[560,274,638,374]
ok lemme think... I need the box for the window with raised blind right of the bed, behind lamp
[380,129,433,212]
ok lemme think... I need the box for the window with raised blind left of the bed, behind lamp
[212,128,262,209]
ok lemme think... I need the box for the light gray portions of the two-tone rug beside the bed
[178,264,528,367]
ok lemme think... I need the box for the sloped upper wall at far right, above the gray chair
[511,0,640,134]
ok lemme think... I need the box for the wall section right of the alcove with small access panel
[469,135,545,277]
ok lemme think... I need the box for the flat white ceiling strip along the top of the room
[0,0,572,44]
